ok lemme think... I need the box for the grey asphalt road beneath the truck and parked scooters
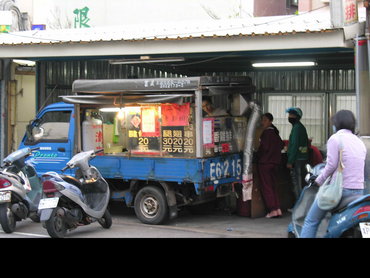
[0,204,290,238]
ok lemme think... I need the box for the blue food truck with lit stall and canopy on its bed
[20,76,254,224]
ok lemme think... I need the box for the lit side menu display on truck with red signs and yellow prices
[126,103,195,157]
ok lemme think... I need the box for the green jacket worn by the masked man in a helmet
[287,121,308,164]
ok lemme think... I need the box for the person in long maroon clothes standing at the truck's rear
[257,113,284,218]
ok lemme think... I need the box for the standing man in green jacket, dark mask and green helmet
[286,107,309,199]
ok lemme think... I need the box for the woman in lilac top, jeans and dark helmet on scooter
[301,110,366,237]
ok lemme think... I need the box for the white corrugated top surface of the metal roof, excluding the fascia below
[0,10,335,45]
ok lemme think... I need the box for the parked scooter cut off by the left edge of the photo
[0,148,42,233]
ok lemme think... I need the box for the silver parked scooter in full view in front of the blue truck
[38,150,112,238]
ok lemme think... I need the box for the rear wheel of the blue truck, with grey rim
[135,186,168,225]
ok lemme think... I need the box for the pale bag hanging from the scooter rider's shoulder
[316,136,344,210]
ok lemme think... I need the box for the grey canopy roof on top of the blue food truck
[61,76,254,105]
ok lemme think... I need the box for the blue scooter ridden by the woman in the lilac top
[288,163,370,238]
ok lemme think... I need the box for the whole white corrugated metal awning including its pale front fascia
[0,8,364,59]
